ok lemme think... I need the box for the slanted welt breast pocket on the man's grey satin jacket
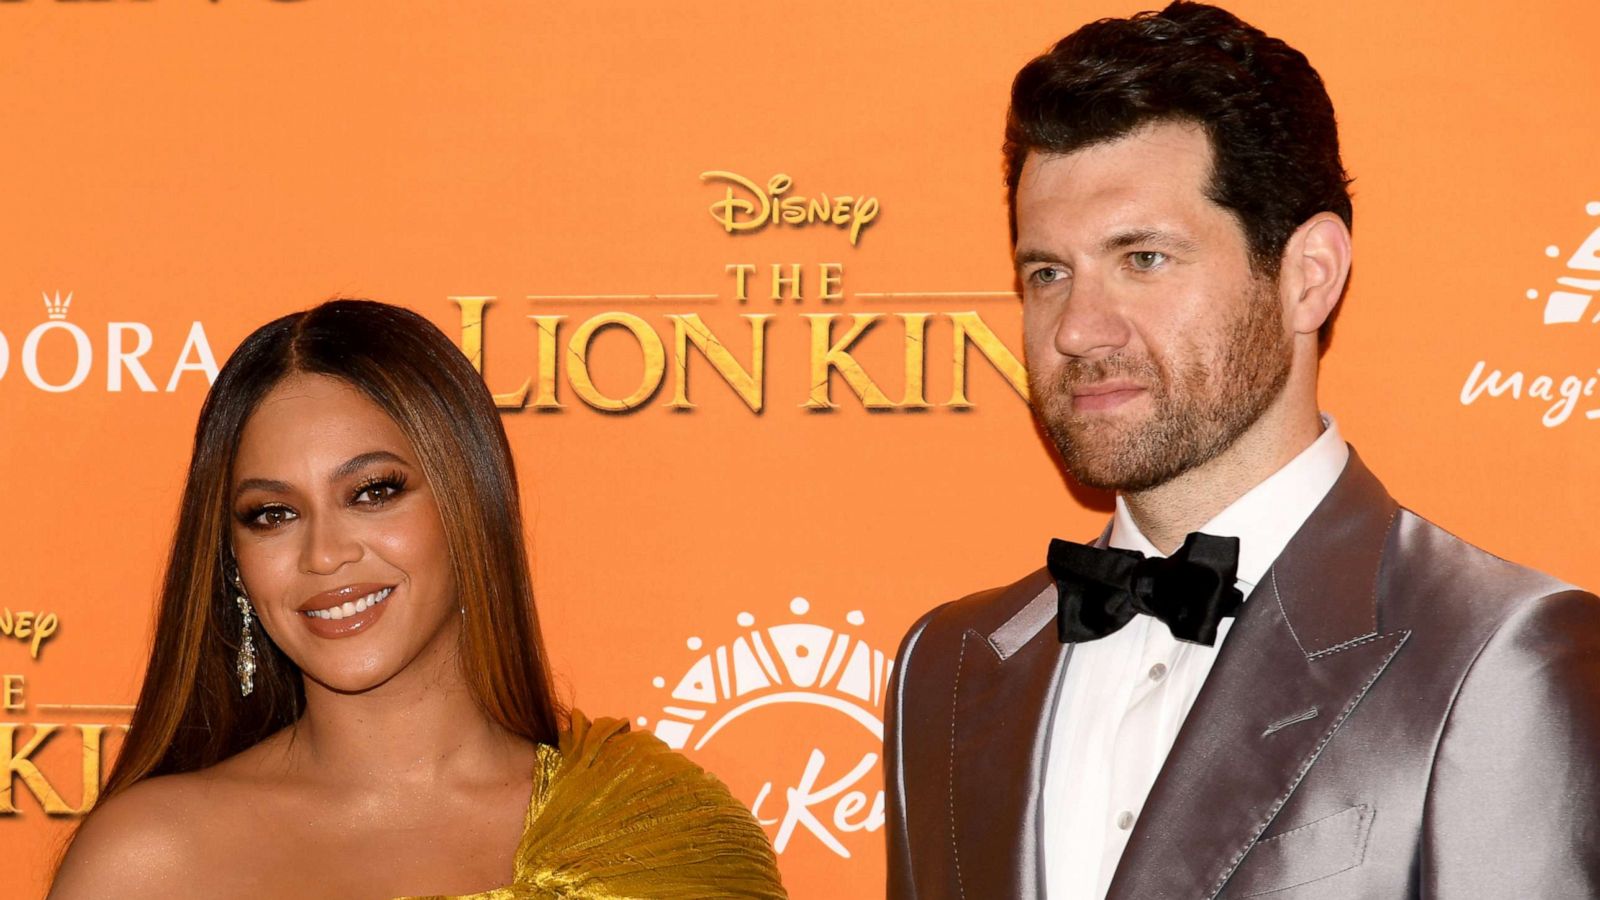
[1224,806,1373,900]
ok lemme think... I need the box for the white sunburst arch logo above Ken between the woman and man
[638,597,894,749]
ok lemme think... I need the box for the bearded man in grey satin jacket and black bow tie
[886,3,1600,900]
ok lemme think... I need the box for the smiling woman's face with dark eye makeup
[229,368,459,692]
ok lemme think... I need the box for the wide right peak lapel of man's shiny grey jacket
[1107,450,1410,900]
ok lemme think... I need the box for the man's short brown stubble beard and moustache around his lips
[1029,279,1293,492]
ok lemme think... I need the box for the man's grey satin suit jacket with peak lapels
[885,452,1600,900]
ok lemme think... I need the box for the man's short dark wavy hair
[1005,0,1352,277]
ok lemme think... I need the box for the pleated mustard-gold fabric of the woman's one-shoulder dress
[400,709,787,900]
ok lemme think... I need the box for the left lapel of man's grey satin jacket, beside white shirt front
[949,572,1069,897]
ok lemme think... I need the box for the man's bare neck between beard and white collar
[1123,404,1322,552]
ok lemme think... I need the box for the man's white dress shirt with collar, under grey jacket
[1043,415,1350,900]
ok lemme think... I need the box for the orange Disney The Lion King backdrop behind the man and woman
[0,0,1600,897]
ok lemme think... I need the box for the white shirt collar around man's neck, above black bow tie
[1109,413,1350,596]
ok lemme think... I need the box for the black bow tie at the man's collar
[1050,532,1245,647]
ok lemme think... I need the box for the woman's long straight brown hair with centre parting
[102,299,563,799]
